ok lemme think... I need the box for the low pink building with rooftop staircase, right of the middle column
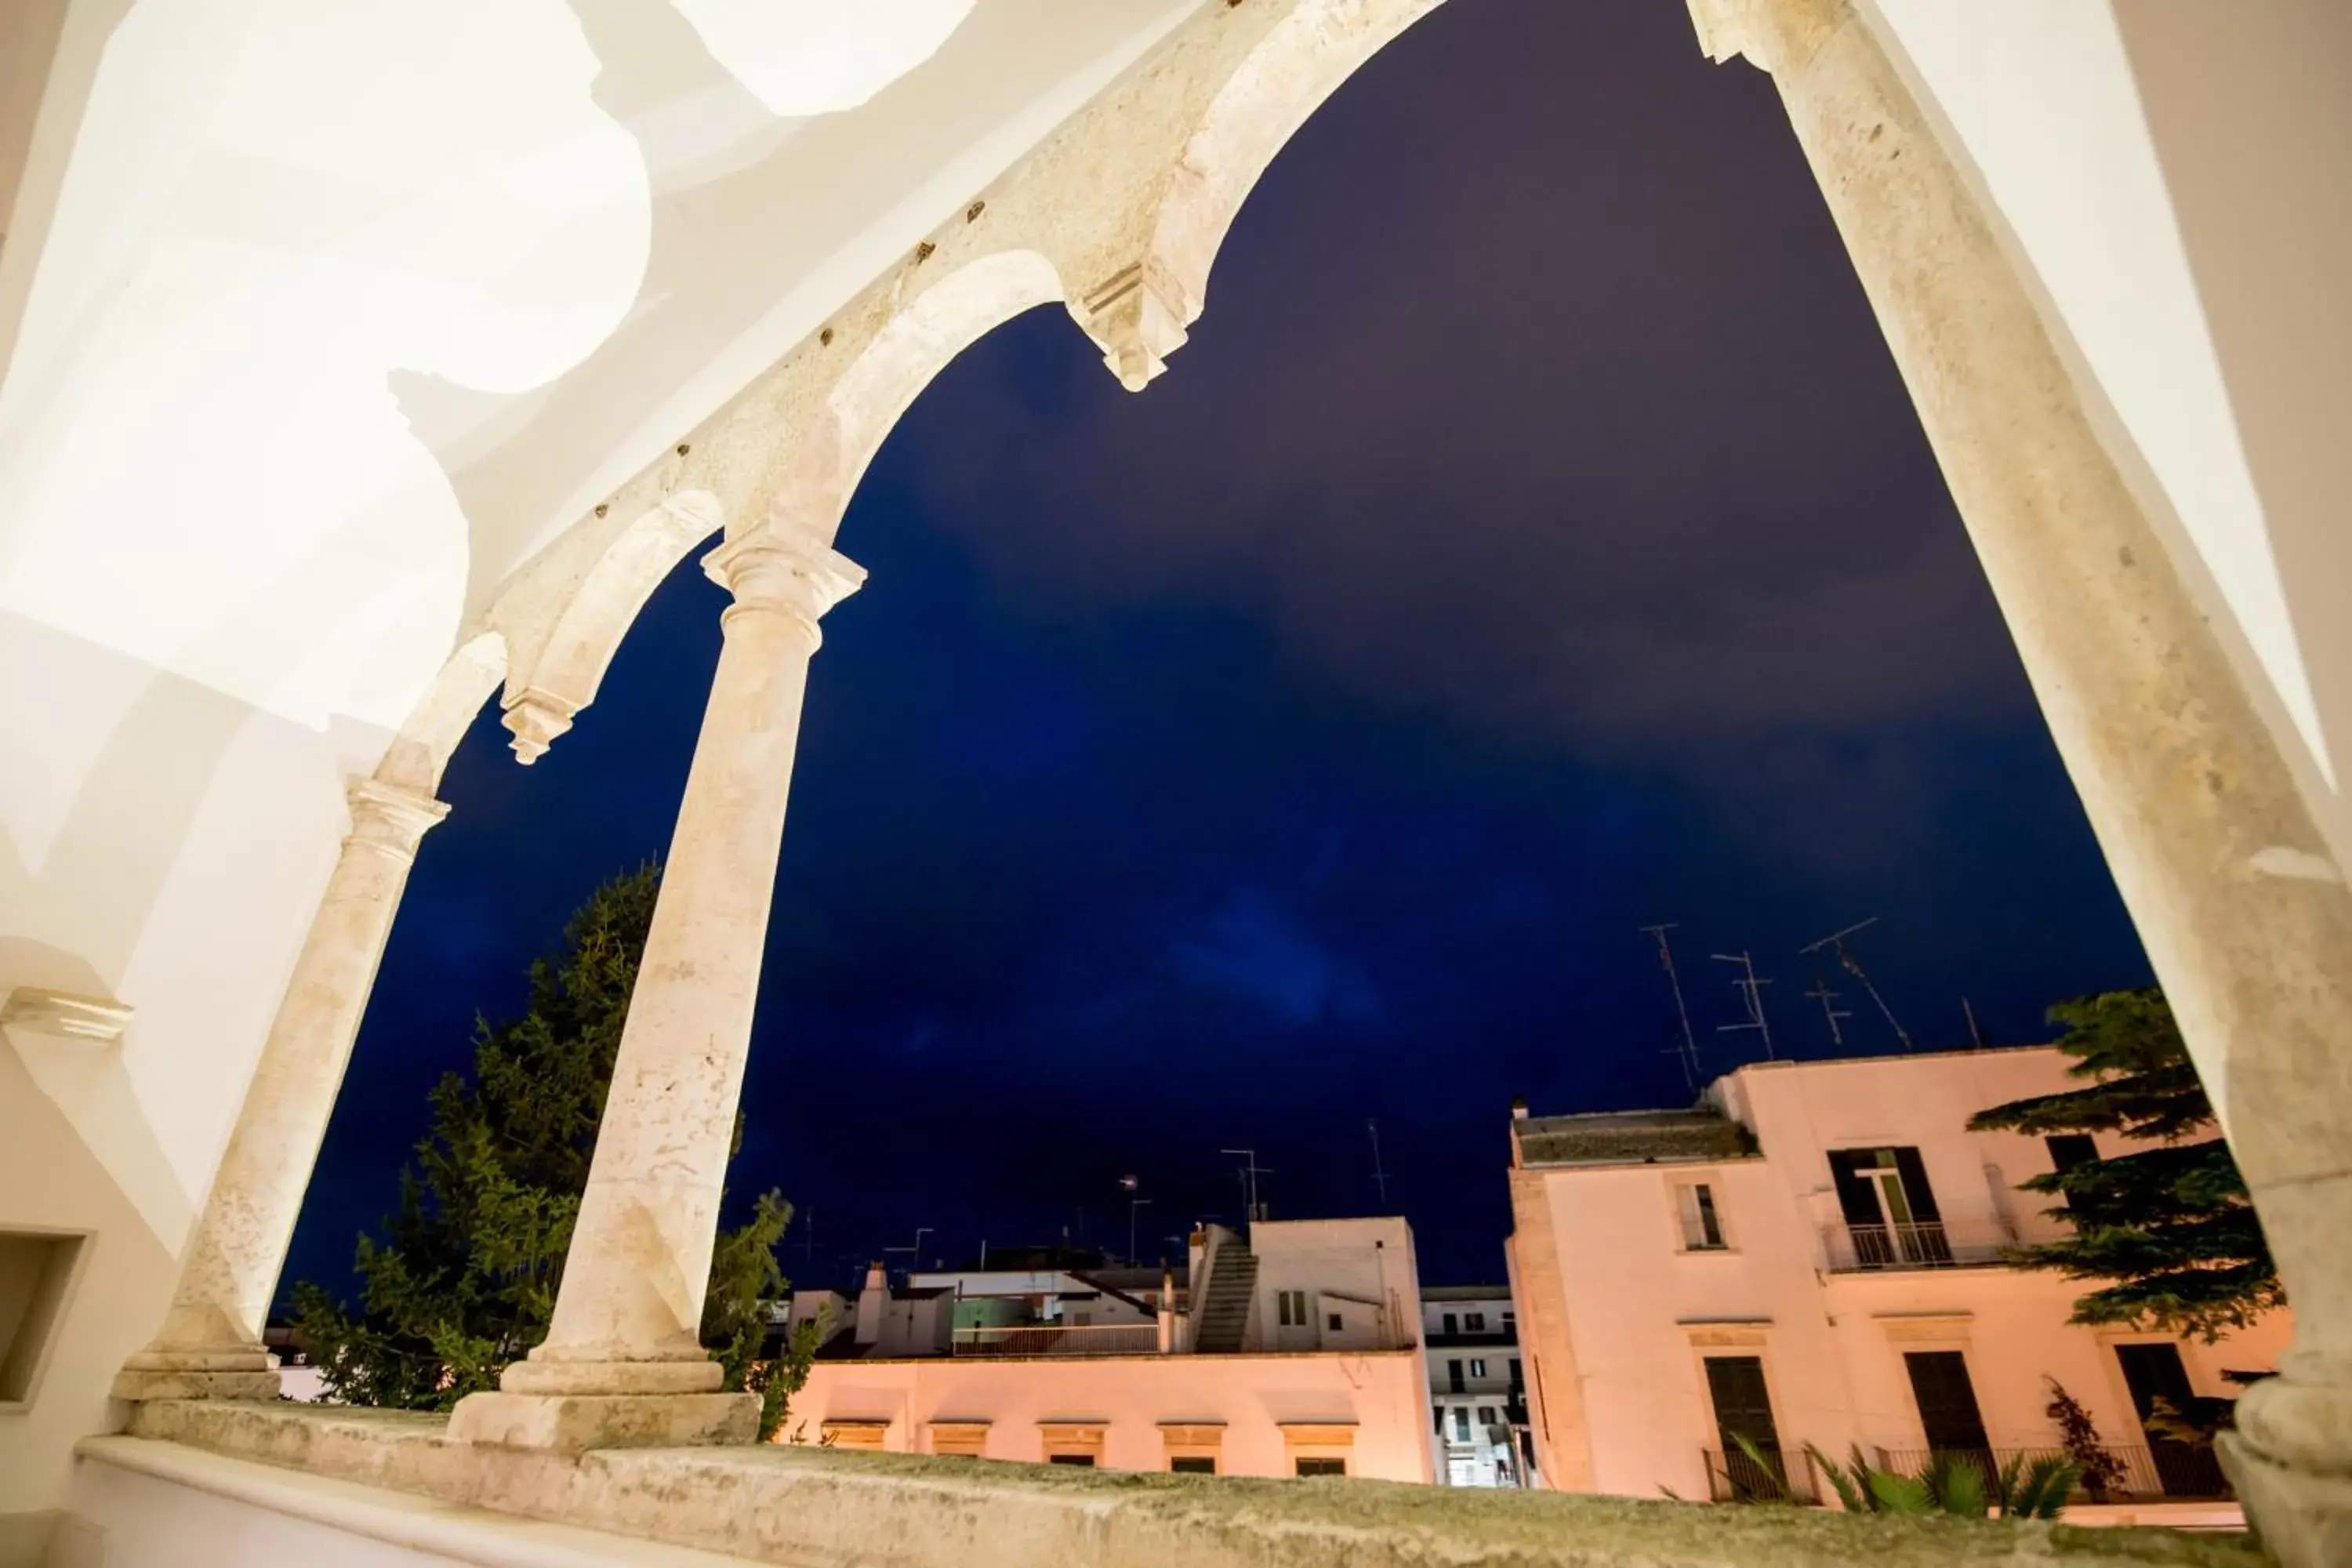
[781,1218,1435,1481]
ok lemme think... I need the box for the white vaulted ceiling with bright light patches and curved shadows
[0,0,1195,729]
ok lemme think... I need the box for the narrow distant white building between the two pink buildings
[1421,1286,1531,1486]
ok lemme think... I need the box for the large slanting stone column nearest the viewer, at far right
[1691,0,2352,1568]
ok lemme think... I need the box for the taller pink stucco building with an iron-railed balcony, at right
[1508,1046,2288,1497]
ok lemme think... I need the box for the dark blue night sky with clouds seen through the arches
[287,0,2147,1283]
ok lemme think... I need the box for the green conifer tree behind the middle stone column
[294,865,814,1436]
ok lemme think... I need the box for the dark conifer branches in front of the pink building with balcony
[1969,987,2286,1342]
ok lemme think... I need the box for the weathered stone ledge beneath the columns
[119,1401,2263,1568]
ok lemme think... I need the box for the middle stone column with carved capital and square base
[449,524,866,1450]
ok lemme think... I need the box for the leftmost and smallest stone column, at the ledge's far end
[113,779,449,1399]
